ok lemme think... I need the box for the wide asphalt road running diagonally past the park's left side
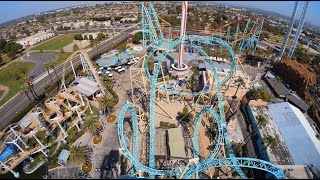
[0,26,137,129]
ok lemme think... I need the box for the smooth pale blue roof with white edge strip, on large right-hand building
[268,102,320,167]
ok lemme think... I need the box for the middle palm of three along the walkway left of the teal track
[81,115,102,137]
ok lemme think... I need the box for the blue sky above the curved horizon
[0,1,320,26]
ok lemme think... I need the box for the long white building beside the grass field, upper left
[17,31,54,48]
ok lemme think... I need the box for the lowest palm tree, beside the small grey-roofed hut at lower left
[69,146,92,164]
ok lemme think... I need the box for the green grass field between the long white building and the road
[31,34,74,50]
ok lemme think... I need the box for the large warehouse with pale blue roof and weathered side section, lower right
[246,102,320,178]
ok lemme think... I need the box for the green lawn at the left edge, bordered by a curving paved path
[0,62,35,105]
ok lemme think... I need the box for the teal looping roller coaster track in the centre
[118,2,284,179]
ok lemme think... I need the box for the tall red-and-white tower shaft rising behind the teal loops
[178,1,188,68]
